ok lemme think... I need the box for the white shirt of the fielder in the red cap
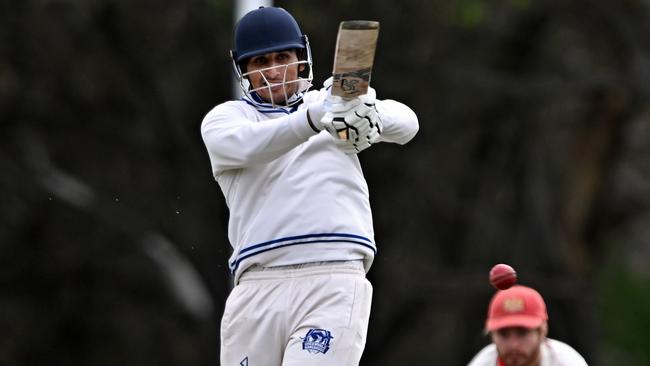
[468,338,587,366]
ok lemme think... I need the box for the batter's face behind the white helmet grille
[246,50,304,104]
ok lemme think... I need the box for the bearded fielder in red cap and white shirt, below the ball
[469,286,587,366]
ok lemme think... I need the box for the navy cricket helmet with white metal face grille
[230,7,313,107]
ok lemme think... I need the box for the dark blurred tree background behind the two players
[0,0,650,366]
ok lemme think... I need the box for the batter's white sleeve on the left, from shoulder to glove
[201,102,314,173]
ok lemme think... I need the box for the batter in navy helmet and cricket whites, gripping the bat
[201,7,418,366]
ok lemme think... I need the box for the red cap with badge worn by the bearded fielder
[485,286,548,332]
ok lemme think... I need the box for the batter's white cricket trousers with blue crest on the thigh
[221,261,372,366]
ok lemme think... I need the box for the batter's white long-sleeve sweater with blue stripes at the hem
[201,89,419,283]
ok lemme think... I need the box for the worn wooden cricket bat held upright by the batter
[332,20,379,140]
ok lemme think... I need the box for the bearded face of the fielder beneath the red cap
[492,327,546,366]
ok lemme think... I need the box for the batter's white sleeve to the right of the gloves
[375,99,420,145]
